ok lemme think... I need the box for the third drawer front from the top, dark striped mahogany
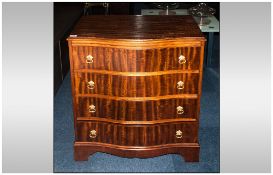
[77,97,197,121]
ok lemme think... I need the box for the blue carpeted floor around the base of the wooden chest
[54,65,220,172]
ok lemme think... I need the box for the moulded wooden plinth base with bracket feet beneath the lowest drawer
[74,142,200,162]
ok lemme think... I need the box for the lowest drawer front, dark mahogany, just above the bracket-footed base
[76,121,198,146]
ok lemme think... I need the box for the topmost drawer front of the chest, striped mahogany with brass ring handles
[72,46,201,72]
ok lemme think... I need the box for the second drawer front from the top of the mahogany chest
[75,73,199,97]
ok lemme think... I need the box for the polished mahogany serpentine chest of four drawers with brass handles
[68,16,206,161]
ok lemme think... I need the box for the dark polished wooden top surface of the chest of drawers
[69,15,204,39]
